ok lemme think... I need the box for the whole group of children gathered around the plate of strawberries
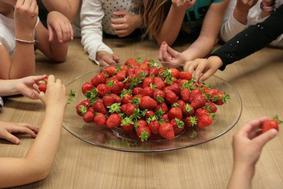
[0,0,283,189]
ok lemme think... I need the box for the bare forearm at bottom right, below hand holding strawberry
[227,165,255,189]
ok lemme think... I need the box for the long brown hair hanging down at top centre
[143,0,168,39]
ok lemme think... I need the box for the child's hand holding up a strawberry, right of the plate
[233,118,277,167]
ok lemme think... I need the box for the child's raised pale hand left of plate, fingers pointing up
[39,75,67,111]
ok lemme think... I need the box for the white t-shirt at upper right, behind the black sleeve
[221,0,283,47]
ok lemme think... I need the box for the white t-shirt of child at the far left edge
[0,14,16,54]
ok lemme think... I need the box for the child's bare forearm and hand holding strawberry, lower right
[227,118,278,189]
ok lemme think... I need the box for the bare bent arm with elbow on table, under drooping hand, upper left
[36,23,68,62]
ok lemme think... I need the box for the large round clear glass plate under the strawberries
[63,72,242,153]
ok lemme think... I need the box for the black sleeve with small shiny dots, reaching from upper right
[211,5,283,70]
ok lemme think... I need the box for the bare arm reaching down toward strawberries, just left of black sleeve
[182,0,228,61]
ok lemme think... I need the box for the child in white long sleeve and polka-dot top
[81,0,143,65]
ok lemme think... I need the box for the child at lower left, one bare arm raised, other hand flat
[0,75,66,188]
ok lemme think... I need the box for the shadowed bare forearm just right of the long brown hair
[154,5,186,45]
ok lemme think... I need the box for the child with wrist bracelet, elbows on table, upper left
[0,0,71,79]
